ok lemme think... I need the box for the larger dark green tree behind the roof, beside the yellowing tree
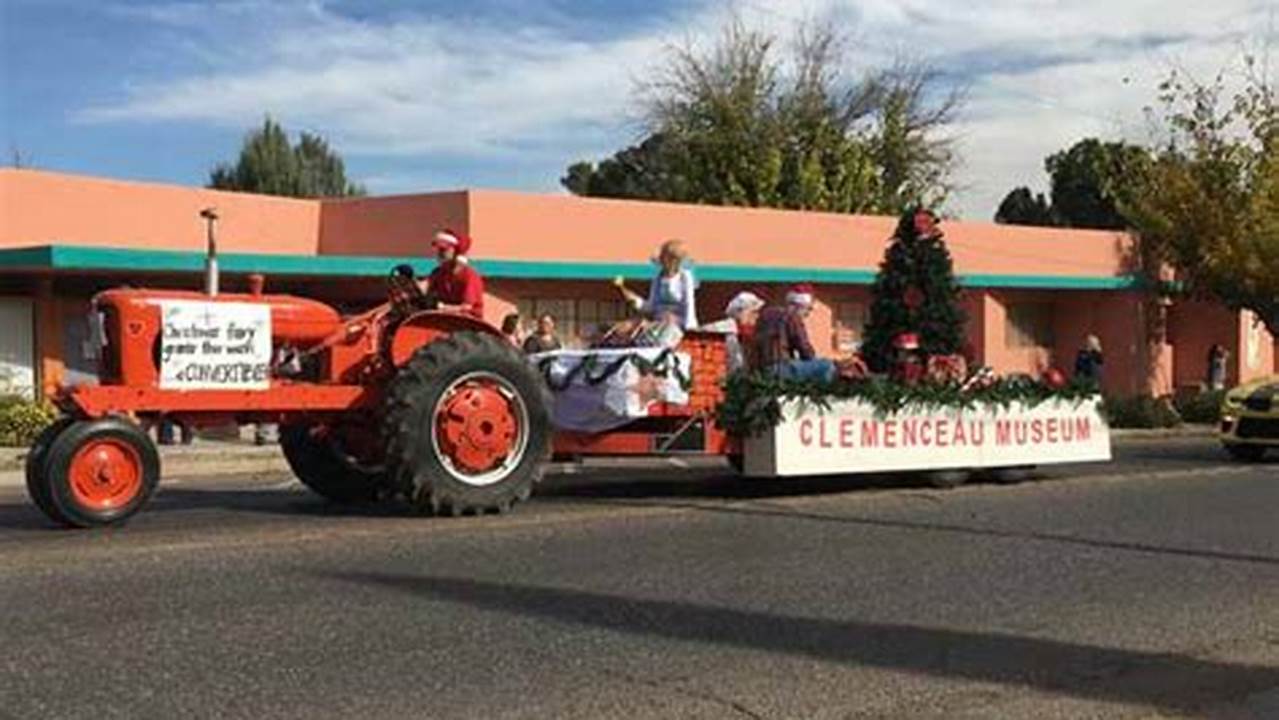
[1044,138,1149,229]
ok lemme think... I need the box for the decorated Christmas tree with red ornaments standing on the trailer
[862,210,967,372]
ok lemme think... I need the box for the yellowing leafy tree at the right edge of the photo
[1120,58,1279,335]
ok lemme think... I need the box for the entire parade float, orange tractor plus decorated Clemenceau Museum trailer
[26,212,1110,527]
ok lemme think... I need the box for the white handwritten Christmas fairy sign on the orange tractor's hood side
[160,301,271,390]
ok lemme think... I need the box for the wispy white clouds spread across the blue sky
[79,0,1273,217]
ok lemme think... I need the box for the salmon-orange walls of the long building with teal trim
[9,169,1276,393]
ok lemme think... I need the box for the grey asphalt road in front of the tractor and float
[0,440,1279,720]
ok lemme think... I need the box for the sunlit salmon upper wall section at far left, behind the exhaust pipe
[0,169,320,254]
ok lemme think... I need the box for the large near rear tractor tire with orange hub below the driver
[384,333,551,515]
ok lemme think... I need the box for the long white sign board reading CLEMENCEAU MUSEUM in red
[743,399,1110,476]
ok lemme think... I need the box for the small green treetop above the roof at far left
[208,118,365,197]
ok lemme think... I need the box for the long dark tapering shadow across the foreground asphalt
[322,573,1279,711]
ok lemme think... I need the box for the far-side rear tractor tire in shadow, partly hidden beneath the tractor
[280,425,386,505]
